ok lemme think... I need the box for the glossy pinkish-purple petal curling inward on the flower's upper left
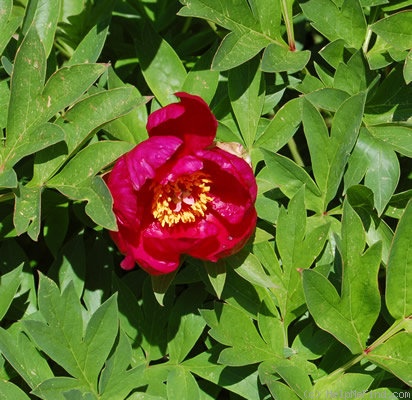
[124,136,182,190]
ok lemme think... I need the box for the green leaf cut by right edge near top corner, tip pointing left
[370,10,412,50]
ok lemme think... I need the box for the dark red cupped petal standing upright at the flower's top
[146,92,217,153]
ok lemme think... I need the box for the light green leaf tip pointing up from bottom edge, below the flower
[167,365,200,400]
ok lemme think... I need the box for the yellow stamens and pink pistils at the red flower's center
[152,172,212,227]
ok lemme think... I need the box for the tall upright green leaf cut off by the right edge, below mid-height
[385,201,412,319]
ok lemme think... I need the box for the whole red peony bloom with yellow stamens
[106,93,256,275]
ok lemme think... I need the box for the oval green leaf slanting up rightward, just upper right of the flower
[254,98,302,152]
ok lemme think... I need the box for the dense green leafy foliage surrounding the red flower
[0,0,412,400]
